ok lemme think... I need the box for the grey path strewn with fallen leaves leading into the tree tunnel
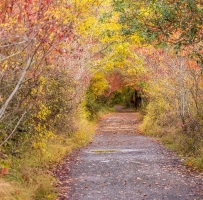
[56,110,203,200]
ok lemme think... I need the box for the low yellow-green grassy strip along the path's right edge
[140,113,203,171]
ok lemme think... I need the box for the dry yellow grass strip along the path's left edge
[0,120,94,200]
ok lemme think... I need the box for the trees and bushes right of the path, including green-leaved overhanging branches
[114,0,203,169]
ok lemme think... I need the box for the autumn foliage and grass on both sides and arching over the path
[0,0,203,200]
